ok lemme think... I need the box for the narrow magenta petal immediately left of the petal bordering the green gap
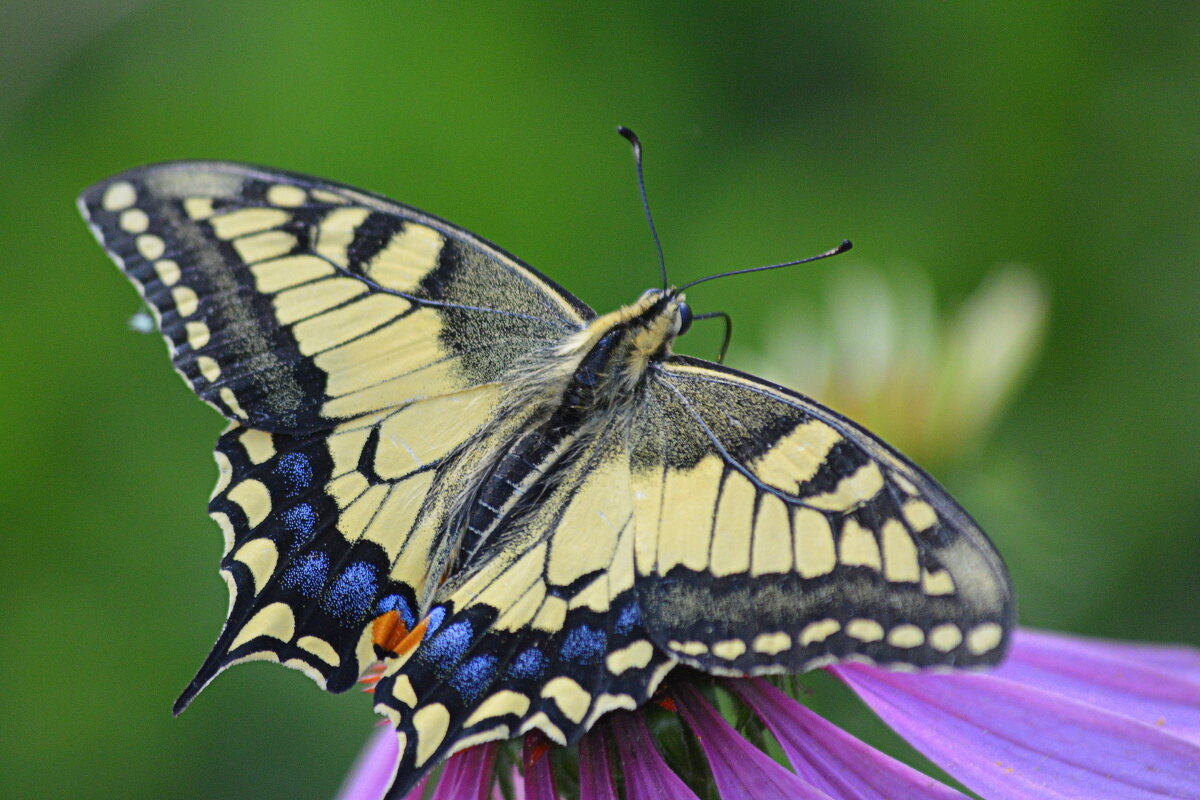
[673,685,830,800]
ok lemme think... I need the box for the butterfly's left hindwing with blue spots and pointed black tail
[178,384,498,708]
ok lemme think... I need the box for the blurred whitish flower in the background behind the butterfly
[744,265,1049,463]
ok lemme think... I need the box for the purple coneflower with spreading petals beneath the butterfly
[340,630,1200,800]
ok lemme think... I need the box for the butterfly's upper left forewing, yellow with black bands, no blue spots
[79,161,593,433]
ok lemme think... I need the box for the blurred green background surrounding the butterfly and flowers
[0,0,1200,798]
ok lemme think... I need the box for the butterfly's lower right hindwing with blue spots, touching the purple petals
[376,434,676,798]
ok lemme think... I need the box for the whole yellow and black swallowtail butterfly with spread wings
[79,145,1015,798]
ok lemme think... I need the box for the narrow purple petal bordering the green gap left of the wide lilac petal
[727,678,966,800]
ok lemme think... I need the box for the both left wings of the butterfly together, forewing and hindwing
[79,162,594,710]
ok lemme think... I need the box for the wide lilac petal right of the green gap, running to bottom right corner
[829,664,1200,800]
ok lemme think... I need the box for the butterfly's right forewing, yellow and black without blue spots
[632,357,1015,674]
